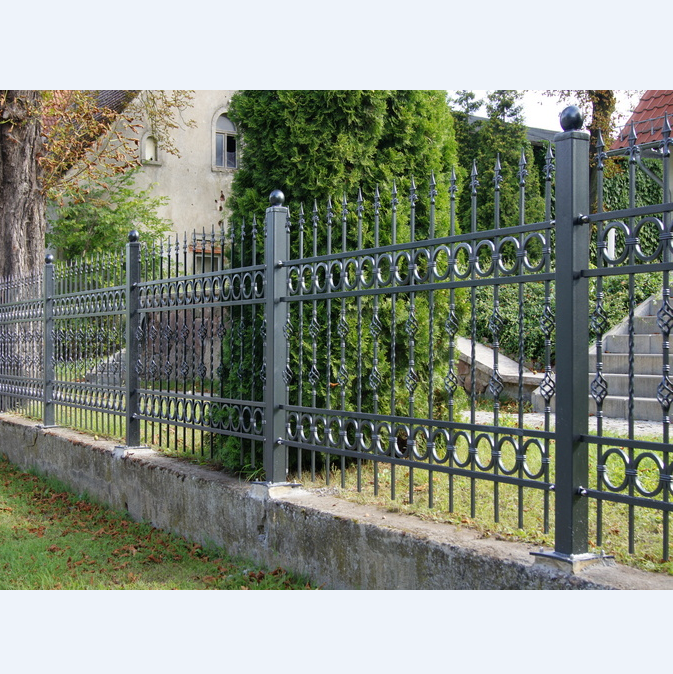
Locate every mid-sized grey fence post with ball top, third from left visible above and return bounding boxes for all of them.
[264,190,289,483]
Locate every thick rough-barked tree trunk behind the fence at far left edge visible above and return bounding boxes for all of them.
[0,90,46,277]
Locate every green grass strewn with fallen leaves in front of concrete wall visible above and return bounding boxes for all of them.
[0,457,315,590]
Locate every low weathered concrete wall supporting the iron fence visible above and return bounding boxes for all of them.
[0,414,673,590]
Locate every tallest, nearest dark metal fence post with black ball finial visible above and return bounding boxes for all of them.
[553,106,595,569]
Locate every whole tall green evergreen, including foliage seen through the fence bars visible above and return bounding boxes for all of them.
[220,91,464,467]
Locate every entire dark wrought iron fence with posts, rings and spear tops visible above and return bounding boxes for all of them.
[0,109,673,562]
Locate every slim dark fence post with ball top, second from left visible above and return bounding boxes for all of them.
[124,229,140,447]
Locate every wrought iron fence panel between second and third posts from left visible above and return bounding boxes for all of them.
[133,223,265,466]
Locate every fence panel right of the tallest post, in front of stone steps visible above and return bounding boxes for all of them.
[583,117,673,560]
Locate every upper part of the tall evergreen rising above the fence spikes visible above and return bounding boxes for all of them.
[229,90,456,238]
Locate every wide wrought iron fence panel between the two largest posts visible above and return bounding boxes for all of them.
[281,162,555,528]
